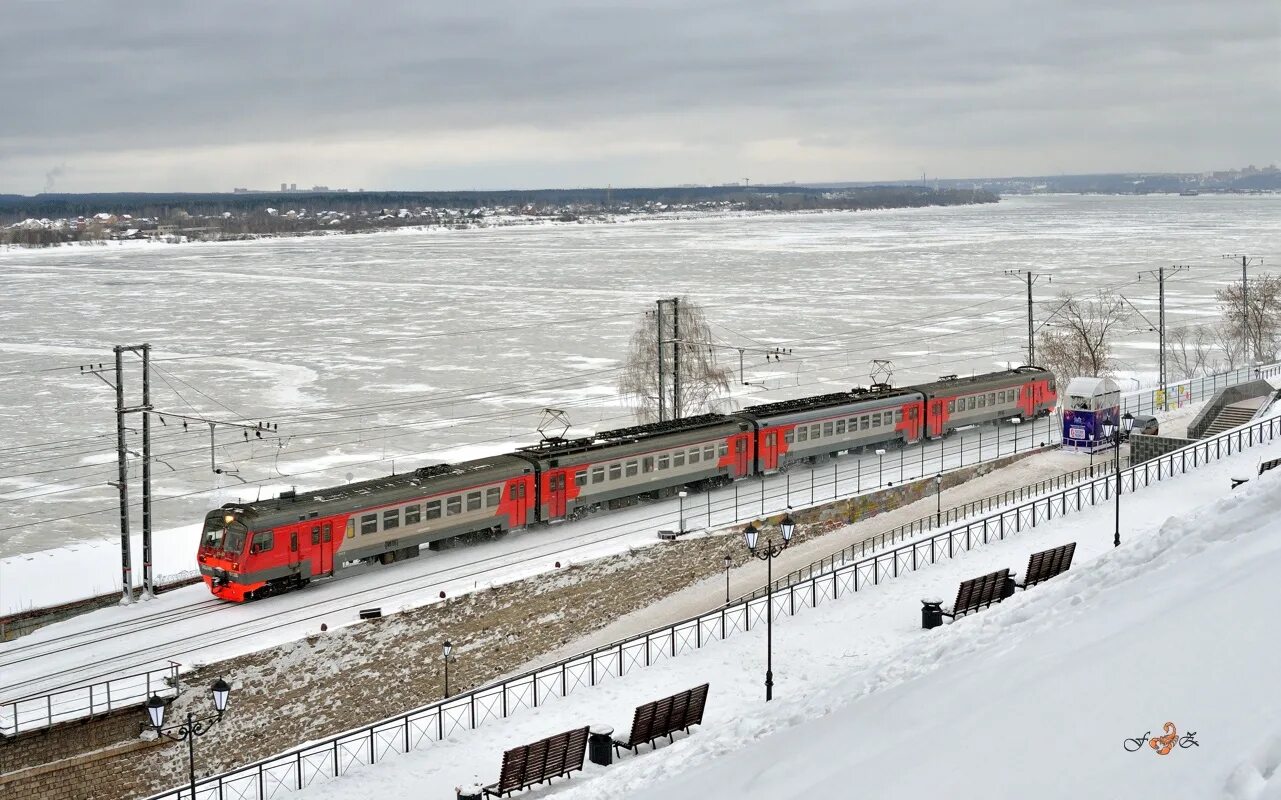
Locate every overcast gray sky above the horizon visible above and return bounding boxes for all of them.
[0,0,1281,193]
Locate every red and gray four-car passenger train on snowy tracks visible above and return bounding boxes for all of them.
[197,366,1057,602]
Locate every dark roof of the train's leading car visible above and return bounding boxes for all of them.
[223,454,532,526]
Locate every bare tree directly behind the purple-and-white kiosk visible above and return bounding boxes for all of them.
[1036,292,1130,383]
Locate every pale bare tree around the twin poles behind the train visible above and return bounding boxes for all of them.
[619,297,730,424]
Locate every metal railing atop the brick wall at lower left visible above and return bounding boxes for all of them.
[0,662,179,737]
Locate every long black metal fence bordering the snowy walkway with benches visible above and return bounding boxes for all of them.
[149,404,1281,800]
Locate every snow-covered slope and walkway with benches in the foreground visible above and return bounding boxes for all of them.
[293,430,1281,800]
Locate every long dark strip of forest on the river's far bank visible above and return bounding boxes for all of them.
[0,186,998,224]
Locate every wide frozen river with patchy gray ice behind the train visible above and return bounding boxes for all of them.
[0,196,1281,557]
